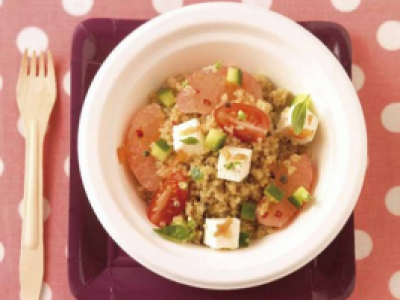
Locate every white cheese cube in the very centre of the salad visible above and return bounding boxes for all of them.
[217,146,252,182]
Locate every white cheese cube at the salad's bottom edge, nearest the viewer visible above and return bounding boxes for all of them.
[203,218,240,249]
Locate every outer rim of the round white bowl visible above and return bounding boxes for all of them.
[78,2,367,289]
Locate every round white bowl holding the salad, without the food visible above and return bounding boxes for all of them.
[78,3,367,289]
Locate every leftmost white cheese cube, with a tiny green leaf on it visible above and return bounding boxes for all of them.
[172,119,204,154]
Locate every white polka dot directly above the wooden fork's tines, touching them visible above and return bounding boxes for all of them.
[17,27,49,53]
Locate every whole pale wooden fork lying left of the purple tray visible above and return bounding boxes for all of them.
[17,50,56,300]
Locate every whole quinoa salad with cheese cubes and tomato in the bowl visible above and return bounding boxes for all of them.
[117,63,319,250]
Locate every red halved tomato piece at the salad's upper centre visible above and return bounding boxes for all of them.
[214,103,271,142]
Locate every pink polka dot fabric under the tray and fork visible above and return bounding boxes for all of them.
[0,0,400,300]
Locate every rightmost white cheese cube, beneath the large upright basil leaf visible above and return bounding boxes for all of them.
[276,106,318,144]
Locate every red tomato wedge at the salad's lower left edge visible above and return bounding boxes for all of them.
[147,172,190,227]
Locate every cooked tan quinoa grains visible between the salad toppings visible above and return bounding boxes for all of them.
[149,74,310,244]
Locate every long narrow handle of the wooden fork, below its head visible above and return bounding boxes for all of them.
[19,119,44,300]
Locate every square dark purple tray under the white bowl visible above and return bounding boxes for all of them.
[68,19,355,300]
